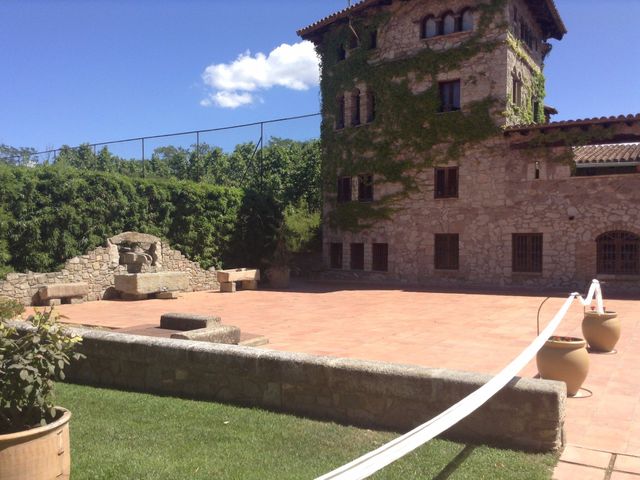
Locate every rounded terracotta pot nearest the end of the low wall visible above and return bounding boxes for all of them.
[536,337,589,396]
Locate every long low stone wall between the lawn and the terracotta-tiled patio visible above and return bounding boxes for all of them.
[17,324,566,451]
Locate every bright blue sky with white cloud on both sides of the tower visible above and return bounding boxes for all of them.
[0,0,640,156]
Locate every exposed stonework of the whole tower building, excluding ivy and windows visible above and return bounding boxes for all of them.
[299,0,640,289]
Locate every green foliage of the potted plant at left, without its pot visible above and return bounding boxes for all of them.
[0,309,81,434]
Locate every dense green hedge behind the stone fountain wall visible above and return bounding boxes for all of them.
[0,166,281,275]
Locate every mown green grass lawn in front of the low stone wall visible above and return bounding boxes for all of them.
[56,384,556,480]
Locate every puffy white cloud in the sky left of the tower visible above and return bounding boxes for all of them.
[200,41,320,108]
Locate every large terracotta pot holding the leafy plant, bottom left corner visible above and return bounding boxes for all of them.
[0,407,71,480]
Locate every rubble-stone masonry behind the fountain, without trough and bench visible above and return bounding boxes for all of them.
[0,232,220,305]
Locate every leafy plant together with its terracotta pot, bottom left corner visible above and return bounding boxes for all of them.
[0,299,81,480]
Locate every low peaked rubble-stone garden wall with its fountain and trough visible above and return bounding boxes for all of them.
[0,232,220,305]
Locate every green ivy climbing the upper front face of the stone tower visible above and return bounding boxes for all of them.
[318,0,505,231]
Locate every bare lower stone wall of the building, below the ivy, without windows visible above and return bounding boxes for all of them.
[324,137,640,294]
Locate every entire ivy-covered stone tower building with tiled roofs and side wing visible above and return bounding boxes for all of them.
[298,0,640,288]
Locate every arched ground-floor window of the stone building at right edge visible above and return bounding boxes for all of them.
[596,231,640,275]
